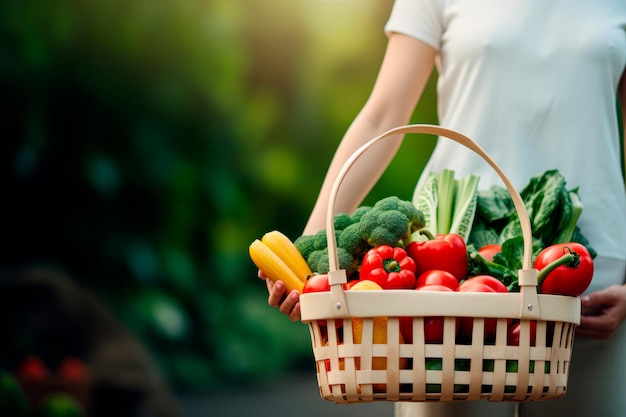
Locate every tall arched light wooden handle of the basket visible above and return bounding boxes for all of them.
[326,124,539,318]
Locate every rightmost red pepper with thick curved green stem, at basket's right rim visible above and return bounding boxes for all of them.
[534,242,594,297]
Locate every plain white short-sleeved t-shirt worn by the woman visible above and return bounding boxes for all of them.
[385,0,626,288]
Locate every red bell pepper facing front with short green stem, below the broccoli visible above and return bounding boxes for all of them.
[359,245,415,290]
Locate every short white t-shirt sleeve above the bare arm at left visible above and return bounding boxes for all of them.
[385,0,444,50]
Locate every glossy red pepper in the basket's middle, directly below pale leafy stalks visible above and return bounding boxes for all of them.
[406,233,467,281]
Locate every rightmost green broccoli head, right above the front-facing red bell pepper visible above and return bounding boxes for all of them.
[359,196,425,246]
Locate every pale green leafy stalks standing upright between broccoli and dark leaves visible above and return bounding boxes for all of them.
[413,169,479,239]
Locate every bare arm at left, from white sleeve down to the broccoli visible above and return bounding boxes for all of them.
[303,34,436,234]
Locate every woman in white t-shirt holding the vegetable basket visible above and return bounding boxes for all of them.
[268,0,626,417]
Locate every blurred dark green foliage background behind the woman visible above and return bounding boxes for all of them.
[0,0,436,391]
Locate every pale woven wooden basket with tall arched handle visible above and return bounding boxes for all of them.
[300,125,580,403]
